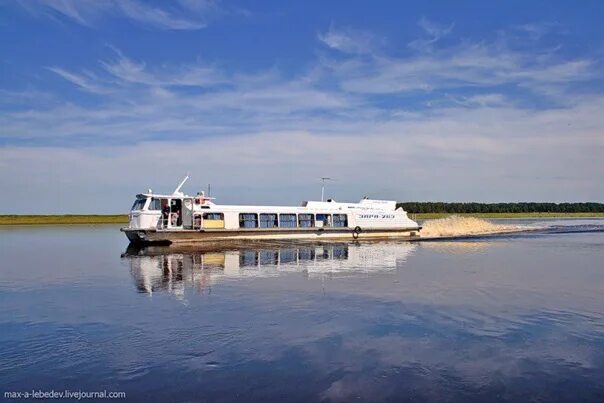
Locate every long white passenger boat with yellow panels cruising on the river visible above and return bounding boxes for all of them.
[121,176,421,244]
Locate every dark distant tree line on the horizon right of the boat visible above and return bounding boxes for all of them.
[396,202,604,213]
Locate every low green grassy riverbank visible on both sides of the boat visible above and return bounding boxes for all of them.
[0,213,604,225]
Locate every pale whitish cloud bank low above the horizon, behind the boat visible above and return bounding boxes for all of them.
[0,94,604,212]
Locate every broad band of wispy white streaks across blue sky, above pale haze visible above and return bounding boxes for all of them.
[2,21,596,144]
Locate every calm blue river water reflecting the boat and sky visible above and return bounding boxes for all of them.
[0,220,604,402]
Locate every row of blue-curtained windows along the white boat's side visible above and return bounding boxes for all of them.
[203,213,348,228]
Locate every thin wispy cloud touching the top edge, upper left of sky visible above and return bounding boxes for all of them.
[20,0,217,30]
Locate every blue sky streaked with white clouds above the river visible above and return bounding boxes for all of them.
[0,0,604,214]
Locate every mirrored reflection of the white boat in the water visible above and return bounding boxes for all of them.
[122,242,416,295]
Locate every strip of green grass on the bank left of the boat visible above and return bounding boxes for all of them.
[0,214,128,225]
